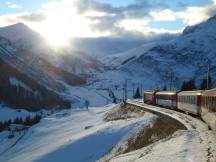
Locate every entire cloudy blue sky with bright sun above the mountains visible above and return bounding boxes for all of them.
[0,0,216,44]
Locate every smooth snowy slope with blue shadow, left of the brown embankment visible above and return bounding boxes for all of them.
[0,105,157,162]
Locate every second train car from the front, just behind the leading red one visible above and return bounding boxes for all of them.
[156,91,177,109]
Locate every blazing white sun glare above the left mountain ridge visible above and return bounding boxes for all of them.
[28,6,107,47]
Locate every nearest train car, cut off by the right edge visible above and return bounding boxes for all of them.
[201,89,216,130]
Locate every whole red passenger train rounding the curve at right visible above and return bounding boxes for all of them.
[144,89,216,130]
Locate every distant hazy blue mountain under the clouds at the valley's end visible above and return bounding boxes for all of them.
[72,34,177,58]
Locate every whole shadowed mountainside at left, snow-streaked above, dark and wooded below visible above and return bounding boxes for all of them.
[0,37,82,111]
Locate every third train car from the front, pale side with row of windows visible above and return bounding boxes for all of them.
[177,91,203,115]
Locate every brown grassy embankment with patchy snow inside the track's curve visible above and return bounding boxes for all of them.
[102,103,187,161]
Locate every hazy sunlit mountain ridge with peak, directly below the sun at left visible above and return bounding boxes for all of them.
[0,23,102,75]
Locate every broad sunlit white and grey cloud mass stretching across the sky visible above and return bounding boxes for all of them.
[0,0,216,37]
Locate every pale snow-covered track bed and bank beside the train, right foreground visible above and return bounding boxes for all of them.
[111,102,216,162]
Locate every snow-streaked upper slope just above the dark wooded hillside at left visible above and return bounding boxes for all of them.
[0,37,85,90]
